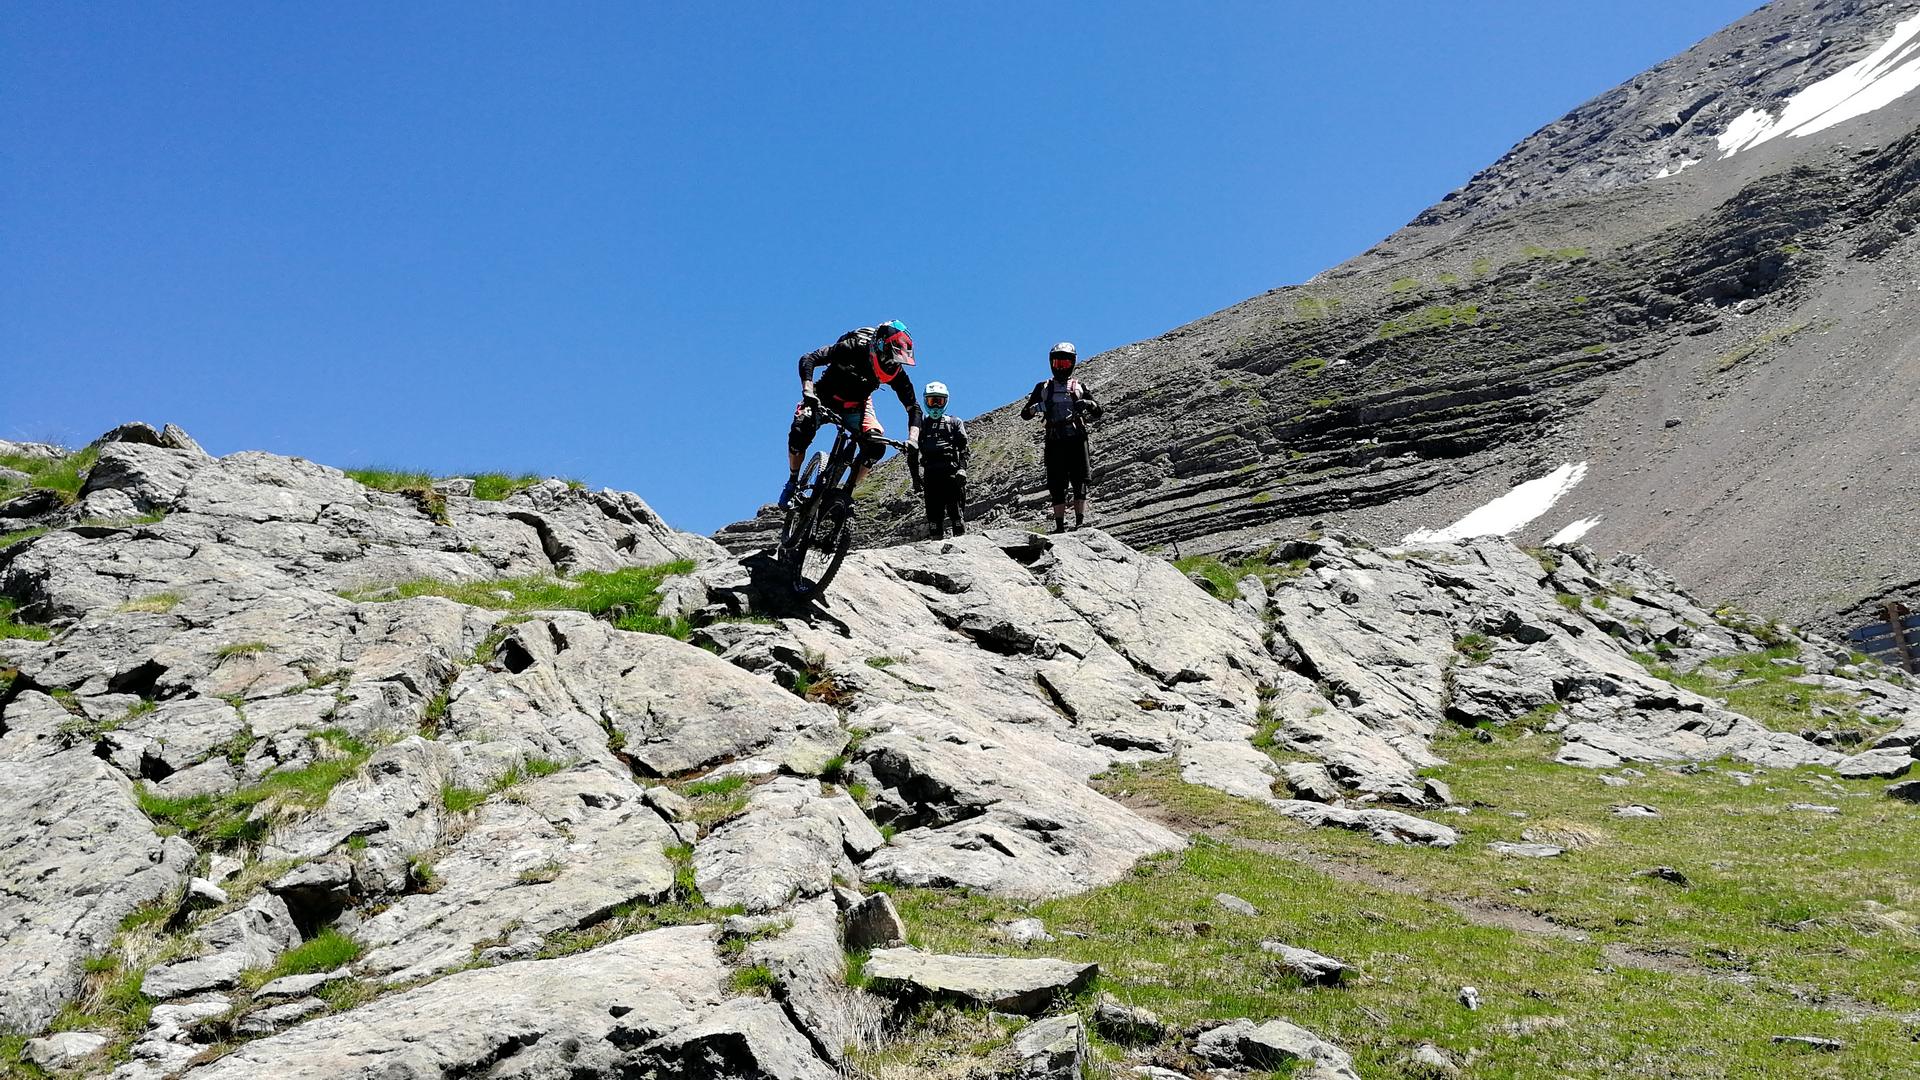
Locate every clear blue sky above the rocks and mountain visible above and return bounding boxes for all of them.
[0,0,1753,530]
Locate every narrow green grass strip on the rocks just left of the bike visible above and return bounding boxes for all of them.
[342,559,693,634]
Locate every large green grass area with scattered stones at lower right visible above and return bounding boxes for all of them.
[891,749,1920,1080]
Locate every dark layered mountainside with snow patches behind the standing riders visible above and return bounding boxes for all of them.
[802,0,1920,628]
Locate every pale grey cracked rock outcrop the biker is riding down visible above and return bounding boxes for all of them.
[0,430,1920,1080]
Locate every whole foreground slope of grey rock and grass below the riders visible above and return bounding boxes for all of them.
[0,425,1920,1080]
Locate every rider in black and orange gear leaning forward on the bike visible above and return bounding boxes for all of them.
[780,319,920,509]
